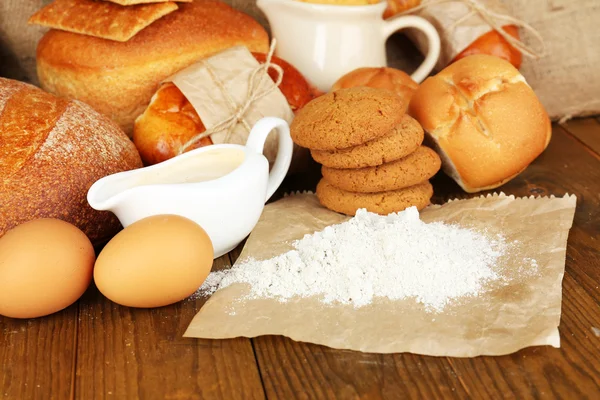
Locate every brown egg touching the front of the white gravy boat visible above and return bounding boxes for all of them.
[94,215,214,308]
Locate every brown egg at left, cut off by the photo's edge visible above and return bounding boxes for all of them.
[0,218,95,318]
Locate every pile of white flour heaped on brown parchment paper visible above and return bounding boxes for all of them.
[199,207,507,312]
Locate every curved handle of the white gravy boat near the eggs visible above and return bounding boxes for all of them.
[246,117,294,201]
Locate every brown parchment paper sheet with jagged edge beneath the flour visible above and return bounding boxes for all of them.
[185,194,576,357]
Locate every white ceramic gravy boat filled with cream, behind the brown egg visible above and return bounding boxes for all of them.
[87,117,293,258]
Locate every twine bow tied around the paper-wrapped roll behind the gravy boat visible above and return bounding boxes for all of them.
[178,39,283,154]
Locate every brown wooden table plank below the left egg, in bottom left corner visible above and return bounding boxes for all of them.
[0,304,78,400]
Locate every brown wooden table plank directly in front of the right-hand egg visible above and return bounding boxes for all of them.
[75,256,264,400]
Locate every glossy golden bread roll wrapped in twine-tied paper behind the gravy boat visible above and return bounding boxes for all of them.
[133,53,315,165]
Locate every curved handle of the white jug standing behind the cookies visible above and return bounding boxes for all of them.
[383,15,441,83]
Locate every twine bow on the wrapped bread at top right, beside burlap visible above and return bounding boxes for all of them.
[400,0,546,59]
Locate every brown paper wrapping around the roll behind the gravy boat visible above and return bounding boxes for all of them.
[165,46,294,162]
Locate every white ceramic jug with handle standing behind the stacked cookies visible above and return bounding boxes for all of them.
[256,0,440,91]
